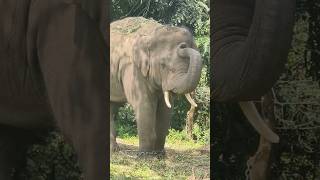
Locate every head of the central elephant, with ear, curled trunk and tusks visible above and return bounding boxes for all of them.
[133,26,202,108]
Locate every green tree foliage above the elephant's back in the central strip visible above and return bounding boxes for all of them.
[111,0,209,31]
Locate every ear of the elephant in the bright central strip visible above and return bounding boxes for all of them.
[133,36,150,77]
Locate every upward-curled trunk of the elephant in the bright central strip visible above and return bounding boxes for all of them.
[171,44,202,94]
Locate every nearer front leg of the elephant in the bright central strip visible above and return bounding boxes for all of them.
[122,70,162,152]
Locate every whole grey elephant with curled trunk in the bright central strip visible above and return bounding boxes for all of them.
[110,17,202,155]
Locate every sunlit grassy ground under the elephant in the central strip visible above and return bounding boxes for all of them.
[110,133,210,180]
